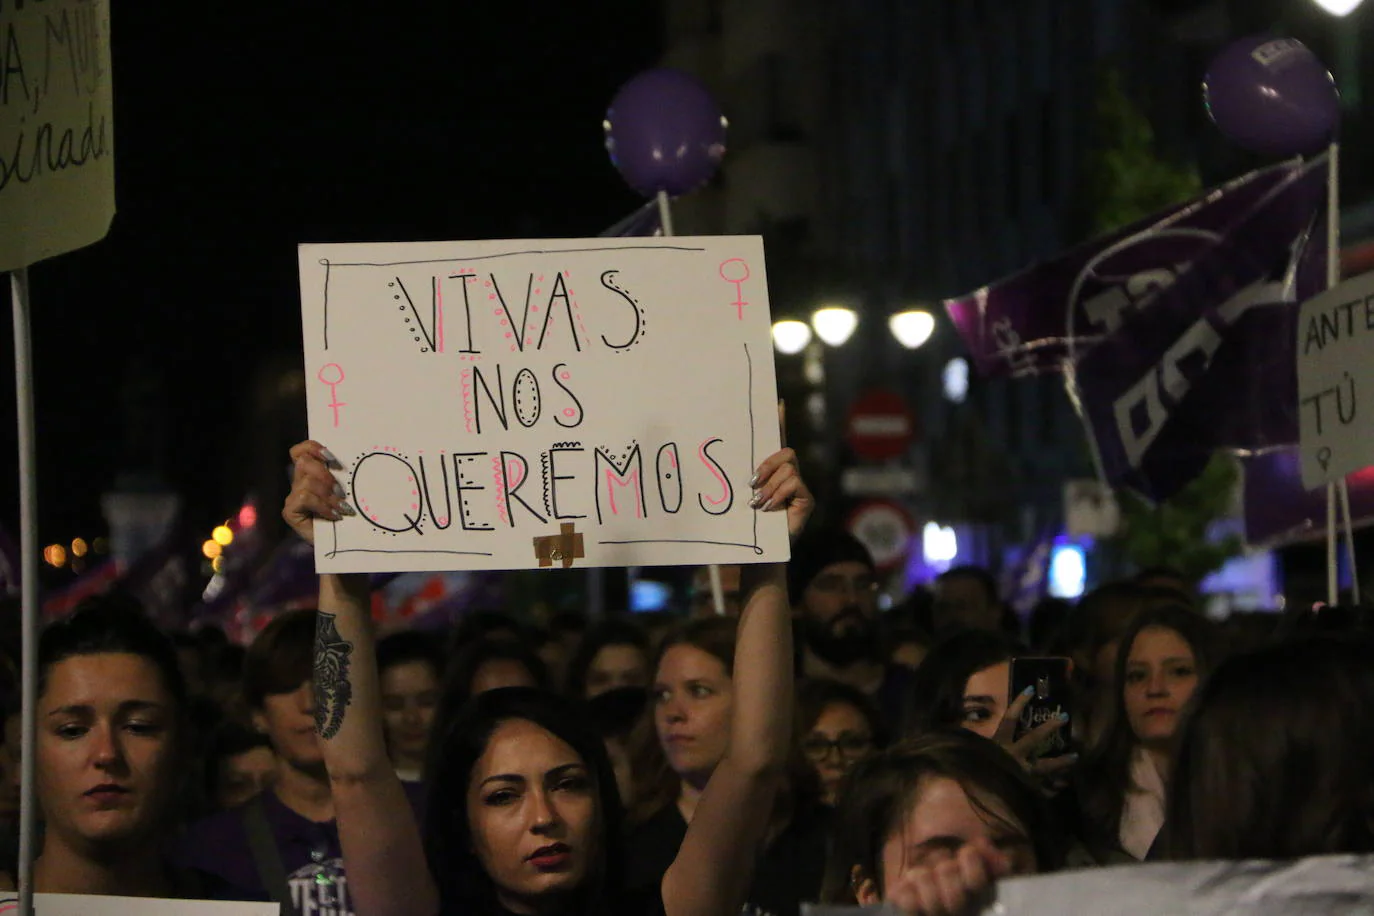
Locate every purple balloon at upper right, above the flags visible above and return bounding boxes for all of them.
[1202,37,1341,157]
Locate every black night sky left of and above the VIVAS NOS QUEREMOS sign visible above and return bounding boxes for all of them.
[0,0,661,552]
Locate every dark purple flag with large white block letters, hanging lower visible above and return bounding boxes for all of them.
[1068,157,1327,500]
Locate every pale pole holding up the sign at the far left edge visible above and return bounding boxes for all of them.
[10,268,38,916]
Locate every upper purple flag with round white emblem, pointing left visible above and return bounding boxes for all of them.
[945,161,1305,376]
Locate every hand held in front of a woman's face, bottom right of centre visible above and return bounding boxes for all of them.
[883,838,1011,916]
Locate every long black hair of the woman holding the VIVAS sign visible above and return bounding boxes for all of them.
[425,687,624,916]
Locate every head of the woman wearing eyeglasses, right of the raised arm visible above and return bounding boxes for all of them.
[797,680,888,808]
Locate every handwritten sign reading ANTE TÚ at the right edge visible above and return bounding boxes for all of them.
[1297,273,1374,489]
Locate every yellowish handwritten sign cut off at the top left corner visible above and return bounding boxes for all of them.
[0,0,114,271]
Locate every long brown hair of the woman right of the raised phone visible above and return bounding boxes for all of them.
[1077,604,1220,851]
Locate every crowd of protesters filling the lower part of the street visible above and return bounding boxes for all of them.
[0,442,1374,916]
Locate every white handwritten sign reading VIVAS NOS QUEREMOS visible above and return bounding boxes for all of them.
[300,238,787,571]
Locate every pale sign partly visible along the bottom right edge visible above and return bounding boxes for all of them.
[801,856,1374,916]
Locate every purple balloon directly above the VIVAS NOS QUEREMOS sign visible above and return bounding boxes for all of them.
[605,69,725,198]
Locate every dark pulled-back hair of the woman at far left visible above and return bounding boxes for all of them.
[38,592,187,714]
